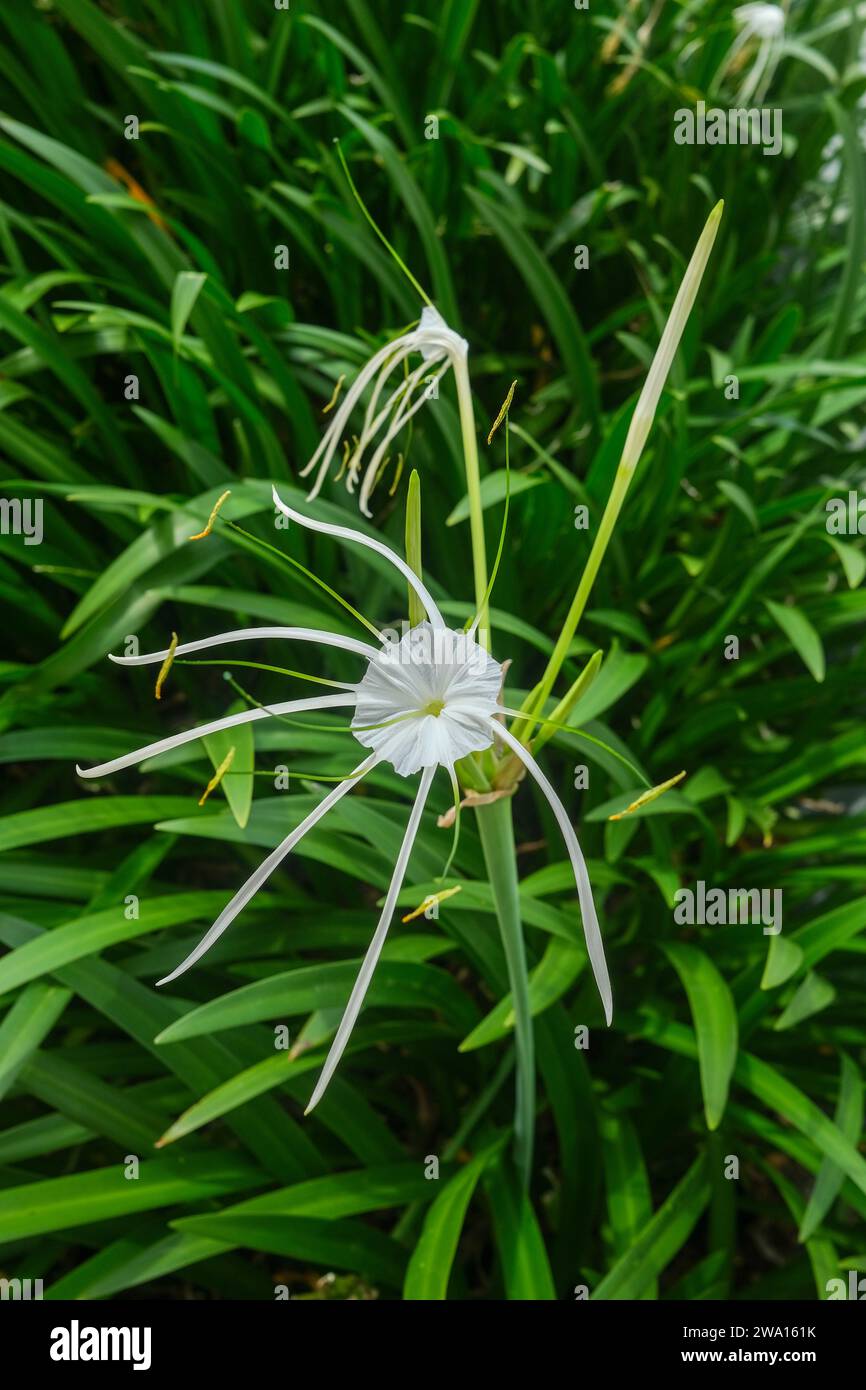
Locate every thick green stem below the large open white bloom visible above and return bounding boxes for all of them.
[475,796,535,1187]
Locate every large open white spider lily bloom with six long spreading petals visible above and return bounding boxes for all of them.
[78,488,613,1113]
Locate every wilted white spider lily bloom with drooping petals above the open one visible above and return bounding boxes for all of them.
[300,304,468,516]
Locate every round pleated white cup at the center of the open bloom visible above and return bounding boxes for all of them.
[352,623,502,777]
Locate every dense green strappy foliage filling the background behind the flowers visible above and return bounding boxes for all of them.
[0,0,866,1300]
